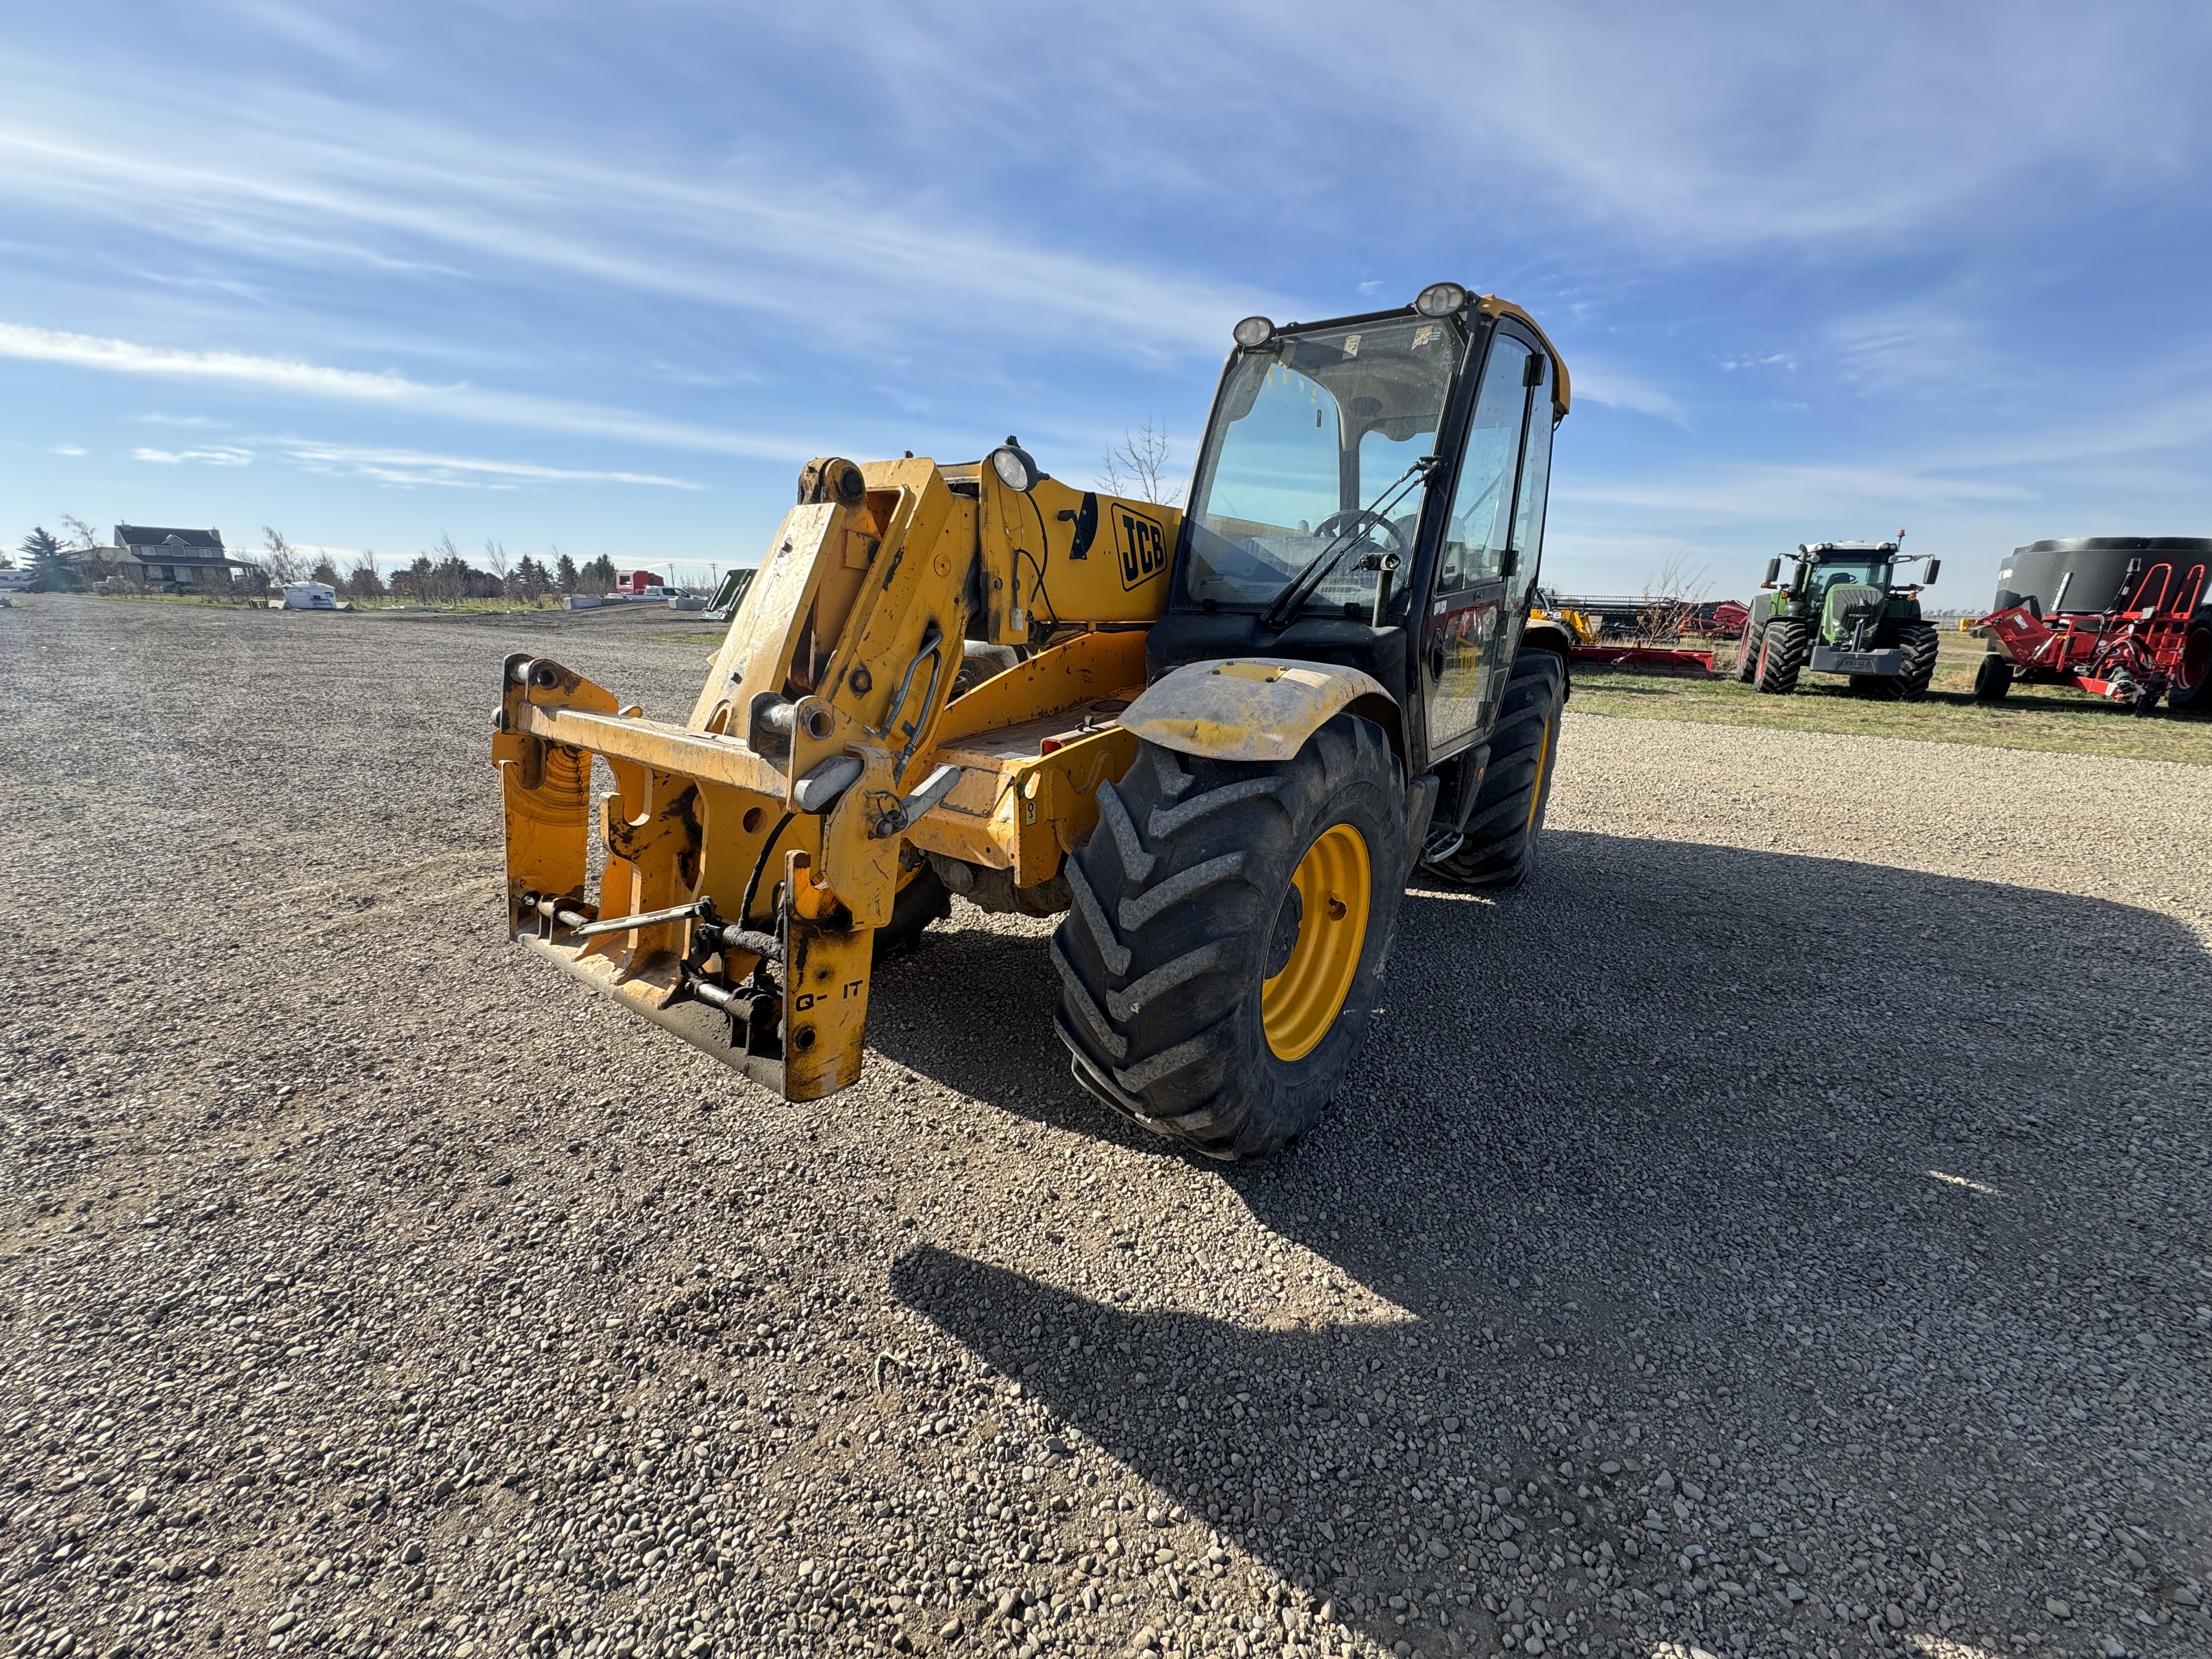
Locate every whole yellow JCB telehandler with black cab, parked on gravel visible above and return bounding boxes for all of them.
[493,283,1568,1157]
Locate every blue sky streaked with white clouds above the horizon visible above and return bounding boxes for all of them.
[0,0,2212,604]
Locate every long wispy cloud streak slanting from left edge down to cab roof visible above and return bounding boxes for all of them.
[0,97,1281,354]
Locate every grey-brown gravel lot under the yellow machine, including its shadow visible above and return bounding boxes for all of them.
[0,600,2212,1659]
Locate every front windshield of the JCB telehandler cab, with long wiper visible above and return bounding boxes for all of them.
[1186,319,1460,613]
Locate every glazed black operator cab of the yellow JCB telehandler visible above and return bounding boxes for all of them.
[1146,283,1568,772]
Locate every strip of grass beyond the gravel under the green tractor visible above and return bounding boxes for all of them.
[1573,633,2212,765]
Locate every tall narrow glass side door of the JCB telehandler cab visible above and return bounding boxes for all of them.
[1420,330,1550,759]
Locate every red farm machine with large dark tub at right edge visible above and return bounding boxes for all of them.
[1973,535,2212,714]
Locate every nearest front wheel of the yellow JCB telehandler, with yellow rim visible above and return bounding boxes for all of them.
[1051,714,1407,1159]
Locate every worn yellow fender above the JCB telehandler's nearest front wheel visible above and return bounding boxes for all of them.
[1121,657,1396,761]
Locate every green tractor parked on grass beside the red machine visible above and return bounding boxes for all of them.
[1736,542,1942,701]
